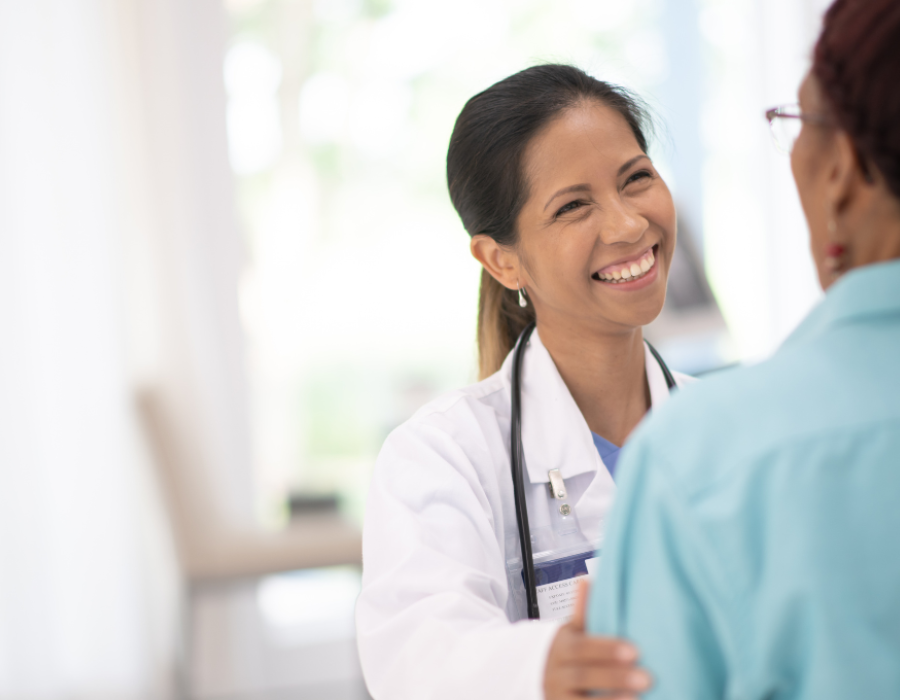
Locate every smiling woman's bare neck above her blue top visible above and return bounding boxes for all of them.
[538,320,650,446]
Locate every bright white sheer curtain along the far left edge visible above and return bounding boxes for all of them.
[0,0,182,700]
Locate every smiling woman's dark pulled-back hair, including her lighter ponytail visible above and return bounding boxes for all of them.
[447,64,649,379]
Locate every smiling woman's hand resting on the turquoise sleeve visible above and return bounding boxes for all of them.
[544,576,650,700]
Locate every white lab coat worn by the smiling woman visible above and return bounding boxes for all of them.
[356,331,690,700]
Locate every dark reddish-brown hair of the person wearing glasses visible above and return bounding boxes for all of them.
[812,0,900,198]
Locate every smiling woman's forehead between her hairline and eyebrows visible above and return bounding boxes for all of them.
[523,102,642,189]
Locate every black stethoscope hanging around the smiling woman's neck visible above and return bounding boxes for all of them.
[509,321,676,620]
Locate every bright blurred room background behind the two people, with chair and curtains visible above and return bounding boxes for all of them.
[0,0,826,700]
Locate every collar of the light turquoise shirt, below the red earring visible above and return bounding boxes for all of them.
[785,260,900,346]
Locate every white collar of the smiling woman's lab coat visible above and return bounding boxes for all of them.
[502,329,669,484]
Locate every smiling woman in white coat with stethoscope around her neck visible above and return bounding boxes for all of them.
[356,65,686,700]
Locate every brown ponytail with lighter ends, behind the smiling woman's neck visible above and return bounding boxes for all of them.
[478,269,534,380]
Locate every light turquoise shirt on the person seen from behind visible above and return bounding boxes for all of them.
[588,261,900,700]
